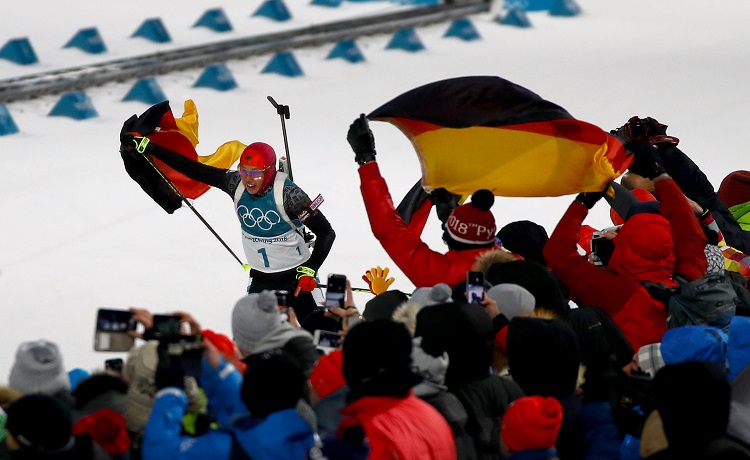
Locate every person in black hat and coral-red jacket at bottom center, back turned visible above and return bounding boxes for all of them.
[338,319,456,460]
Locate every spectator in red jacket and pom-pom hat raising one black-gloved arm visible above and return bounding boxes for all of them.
[346,114,496,288]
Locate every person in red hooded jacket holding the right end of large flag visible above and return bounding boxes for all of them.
[544,146,706,350]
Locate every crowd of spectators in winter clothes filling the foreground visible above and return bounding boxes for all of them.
[0,113,750,460]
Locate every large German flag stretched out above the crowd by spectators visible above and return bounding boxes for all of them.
[368,76,632,197]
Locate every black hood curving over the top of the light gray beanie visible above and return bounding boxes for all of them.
[484,260,570,318]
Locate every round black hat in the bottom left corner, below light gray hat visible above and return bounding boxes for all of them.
[5,393,73,452]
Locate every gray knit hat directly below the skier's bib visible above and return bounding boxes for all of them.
[232,291,282,353]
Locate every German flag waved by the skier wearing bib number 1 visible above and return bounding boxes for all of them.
[121,100,246,214]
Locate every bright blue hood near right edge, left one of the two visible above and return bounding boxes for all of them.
[661,325,729,368]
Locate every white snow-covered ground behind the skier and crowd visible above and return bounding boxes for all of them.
[0,0,750,384]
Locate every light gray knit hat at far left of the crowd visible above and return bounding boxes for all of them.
[8,339,70,395]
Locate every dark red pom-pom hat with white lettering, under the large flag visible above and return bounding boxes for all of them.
[445,189,496,245]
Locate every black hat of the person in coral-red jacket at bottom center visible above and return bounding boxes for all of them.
[343,320,422,400]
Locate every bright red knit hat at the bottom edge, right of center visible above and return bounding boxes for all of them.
[500,396,563,452]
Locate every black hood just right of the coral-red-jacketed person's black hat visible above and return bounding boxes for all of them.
[414,302,495,386]
